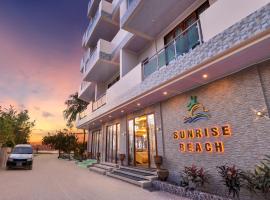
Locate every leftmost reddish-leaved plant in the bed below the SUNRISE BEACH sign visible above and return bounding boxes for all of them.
[180,165,209,191]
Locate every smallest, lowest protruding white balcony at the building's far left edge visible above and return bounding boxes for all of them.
[78,81,95,102]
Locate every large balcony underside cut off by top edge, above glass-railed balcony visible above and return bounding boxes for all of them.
[120,0,196,40]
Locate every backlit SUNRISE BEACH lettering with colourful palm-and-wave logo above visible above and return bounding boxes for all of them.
[173,96,232,153]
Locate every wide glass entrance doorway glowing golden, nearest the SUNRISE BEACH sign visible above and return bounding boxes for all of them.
[128,114,156,167]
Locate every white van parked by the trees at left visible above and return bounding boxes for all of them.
[6,144,33,170]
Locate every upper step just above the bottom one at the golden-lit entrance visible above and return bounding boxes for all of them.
[114,167,157,181]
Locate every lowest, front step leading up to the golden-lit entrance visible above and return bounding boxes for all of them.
[107,170,152,188]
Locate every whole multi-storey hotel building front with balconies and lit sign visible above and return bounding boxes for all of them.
[77,0,270,197]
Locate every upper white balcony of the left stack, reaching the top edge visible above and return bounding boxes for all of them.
[82,0,119,47]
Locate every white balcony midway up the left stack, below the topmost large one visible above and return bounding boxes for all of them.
[83,39,119,82]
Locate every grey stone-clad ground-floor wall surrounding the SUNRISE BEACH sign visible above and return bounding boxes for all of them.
[162,62,270,199]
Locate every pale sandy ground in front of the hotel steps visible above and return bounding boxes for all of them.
[0,155,190,200]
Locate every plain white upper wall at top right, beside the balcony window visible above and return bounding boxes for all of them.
[200,0,270,42]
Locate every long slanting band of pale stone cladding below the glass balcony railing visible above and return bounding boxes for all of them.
[79,3,270,124]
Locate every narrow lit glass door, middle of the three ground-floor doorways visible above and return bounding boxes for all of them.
[105,124,120,163]
